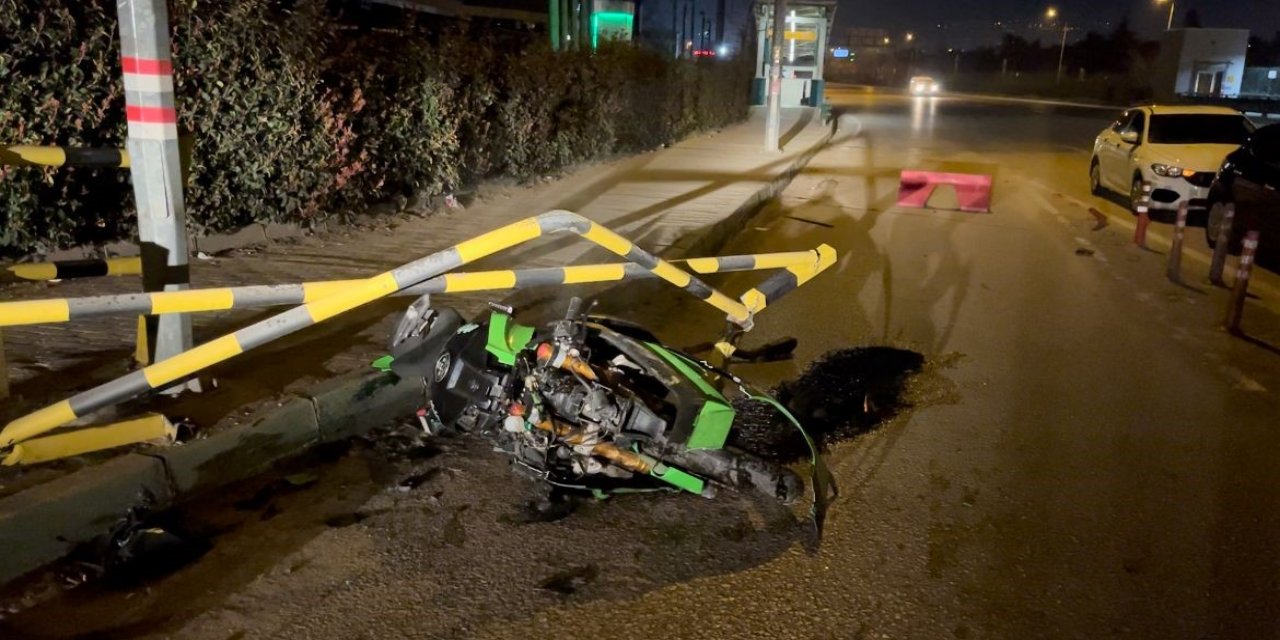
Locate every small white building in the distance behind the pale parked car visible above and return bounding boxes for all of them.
[1152,28,1249,100]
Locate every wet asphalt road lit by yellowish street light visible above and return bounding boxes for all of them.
[0,88,1280,640]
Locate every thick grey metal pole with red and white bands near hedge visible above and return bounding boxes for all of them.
[116,0,191,376]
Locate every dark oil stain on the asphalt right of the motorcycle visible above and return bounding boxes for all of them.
[730,347,924,462]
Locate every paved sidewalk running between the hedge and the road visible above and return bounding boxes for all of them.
[0,110,833,582]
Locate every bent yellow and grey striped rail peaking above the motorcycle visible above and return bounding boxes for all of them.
[0,210,835,448]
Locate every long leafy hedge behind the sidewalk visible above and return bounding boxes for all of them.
[0,0,751,256]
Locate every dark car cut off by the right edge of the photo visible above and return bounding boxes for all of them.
[1204,124,1280,266]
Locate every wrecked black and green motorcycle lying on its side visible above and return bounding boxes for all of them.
[376,296,836,530]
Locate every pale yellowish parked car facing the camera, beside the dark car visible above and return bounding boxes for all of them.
[1089,105,1254,211]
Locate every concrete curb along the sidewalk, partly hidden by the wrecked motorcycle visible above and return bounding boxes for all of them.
[0,122,836,584]
